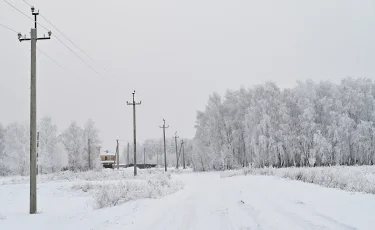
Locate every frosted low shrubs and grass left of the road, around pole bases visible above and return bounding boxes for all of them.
[0,168,183,208]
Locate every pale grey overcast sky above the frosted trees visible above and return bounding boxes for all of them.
[0,0,375,151]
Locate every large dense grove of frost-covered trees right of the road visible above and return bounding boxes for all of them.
[192,78,375,170]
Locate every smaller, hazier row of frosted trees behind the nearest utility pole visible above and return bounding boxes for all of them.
[0,117,100,175]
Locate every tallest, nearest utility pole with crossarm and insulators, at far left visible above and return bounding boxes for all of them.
[18,7,52,214]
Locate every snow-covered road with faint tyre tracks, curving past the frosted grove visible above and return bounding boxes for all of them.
[134,173,375,230]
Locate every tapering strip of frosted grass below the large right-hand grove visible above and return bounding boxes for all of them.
[221,166,375,194]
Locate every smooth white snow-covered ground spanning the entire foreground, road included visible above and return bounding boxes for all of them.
[0,169,375,230]
